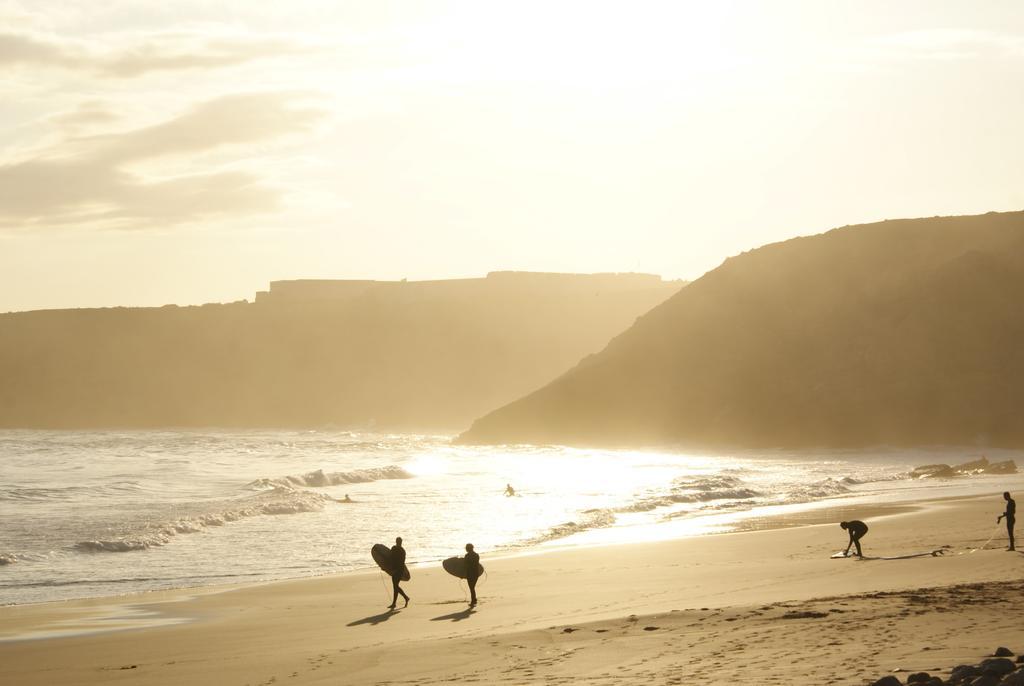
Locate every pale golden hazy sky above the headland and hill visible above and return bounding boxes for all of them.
[0,0,1024,311]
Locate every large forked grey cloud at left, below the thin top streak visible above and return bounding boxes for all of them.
[0,93,322,230]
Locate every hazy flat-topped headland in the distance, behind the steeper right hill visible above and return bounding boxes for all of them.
[0,271,683,430]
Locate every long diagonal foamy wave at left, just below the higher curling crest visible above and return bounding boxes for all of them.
[74,486,331,553]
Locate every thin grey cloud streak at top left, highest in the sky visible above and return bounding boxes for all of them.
[0,31,305,78]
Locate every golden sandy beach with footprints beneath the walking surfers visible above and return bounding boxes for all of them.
[0,494,1024,686]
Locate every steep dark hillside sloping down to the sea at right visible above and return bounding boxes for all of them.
[461,212,1024,447]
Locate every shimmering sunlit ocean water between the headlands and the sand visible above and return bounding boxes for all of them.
[0,431,1021,604]
